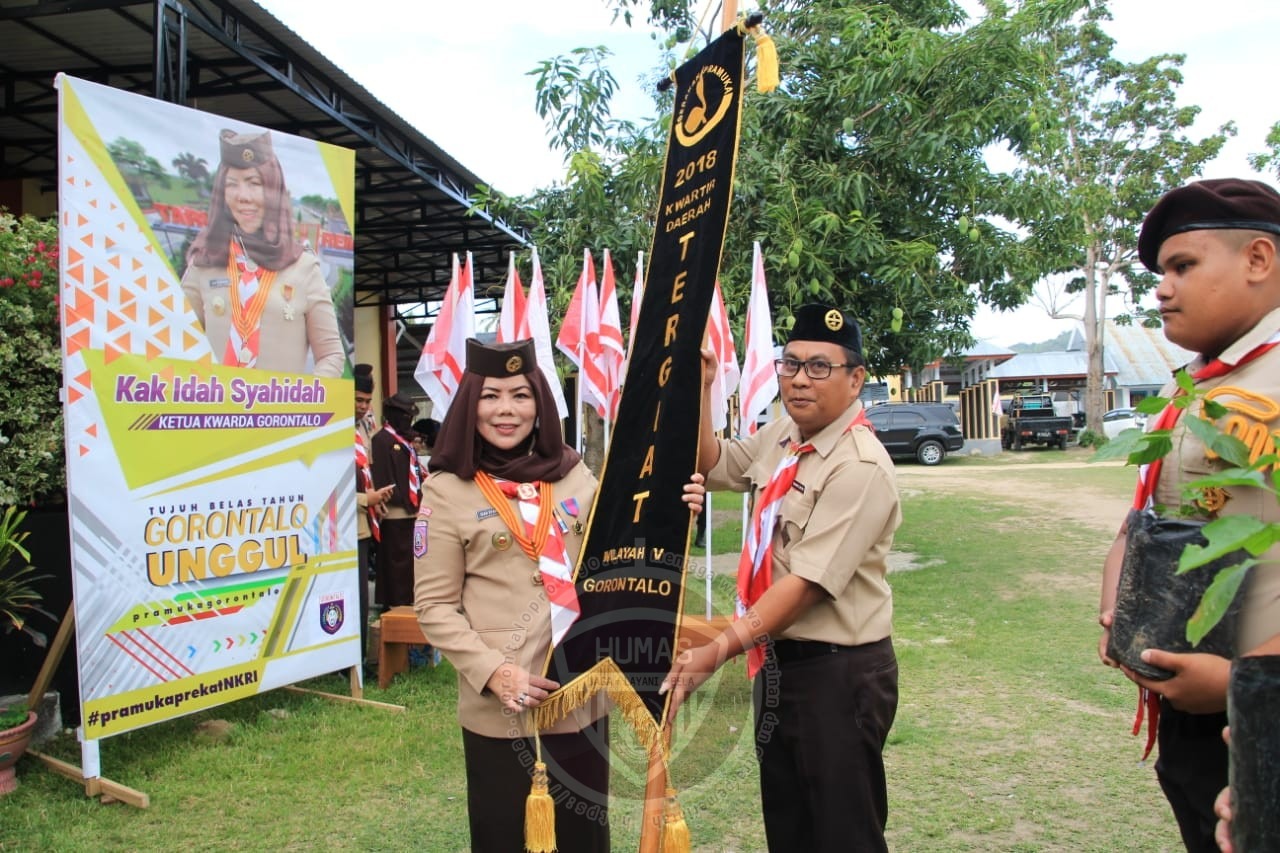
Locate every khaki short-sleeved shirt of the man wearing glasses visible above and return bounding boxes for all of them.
[707,402,902,646]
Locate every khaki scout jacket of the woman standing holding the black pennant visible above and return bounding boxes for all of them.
[413,462,607,738]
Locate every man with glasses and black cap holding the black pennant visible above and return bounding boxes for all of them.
[663,305,901,852]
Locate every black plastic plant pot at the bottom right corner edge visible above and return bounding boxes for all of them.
[1226,654,1280,853]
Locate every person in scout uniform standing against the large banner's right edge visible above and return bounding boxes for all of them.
[371,391,422,607]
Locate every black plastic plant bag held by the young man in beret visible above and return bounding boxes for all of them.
[1107,510,1248,679]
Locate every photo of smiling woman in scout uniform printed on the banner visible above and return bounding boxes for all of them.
[182,129,346,377]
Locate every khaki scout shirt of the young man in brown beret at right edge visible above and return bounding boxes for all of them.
[1155,309,1280,653]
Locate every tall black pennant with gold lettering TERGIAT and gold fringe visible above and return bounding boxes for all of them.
[548,29,742,724]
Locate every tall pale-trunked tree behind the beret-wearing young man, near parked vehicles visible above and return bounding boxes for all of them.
[1011,4,1235,429]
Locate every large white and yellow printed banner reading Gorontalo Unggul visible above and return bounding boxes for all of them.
[58,76,362,739]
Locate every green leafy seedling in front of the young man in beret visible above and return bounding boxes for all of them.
[1093,370,1280,646]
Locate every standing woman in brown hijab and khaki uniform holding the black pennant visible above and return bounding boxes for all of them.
[413,338,704,853]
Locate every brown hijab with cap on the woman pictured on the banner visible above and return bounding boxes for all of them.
[187,131,302,270]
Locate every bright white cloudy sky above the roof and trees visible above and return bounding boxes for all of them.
[259,0,1280,346]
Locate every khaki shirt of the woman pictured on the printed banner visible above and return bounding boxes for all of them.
[182,252,346,377]
